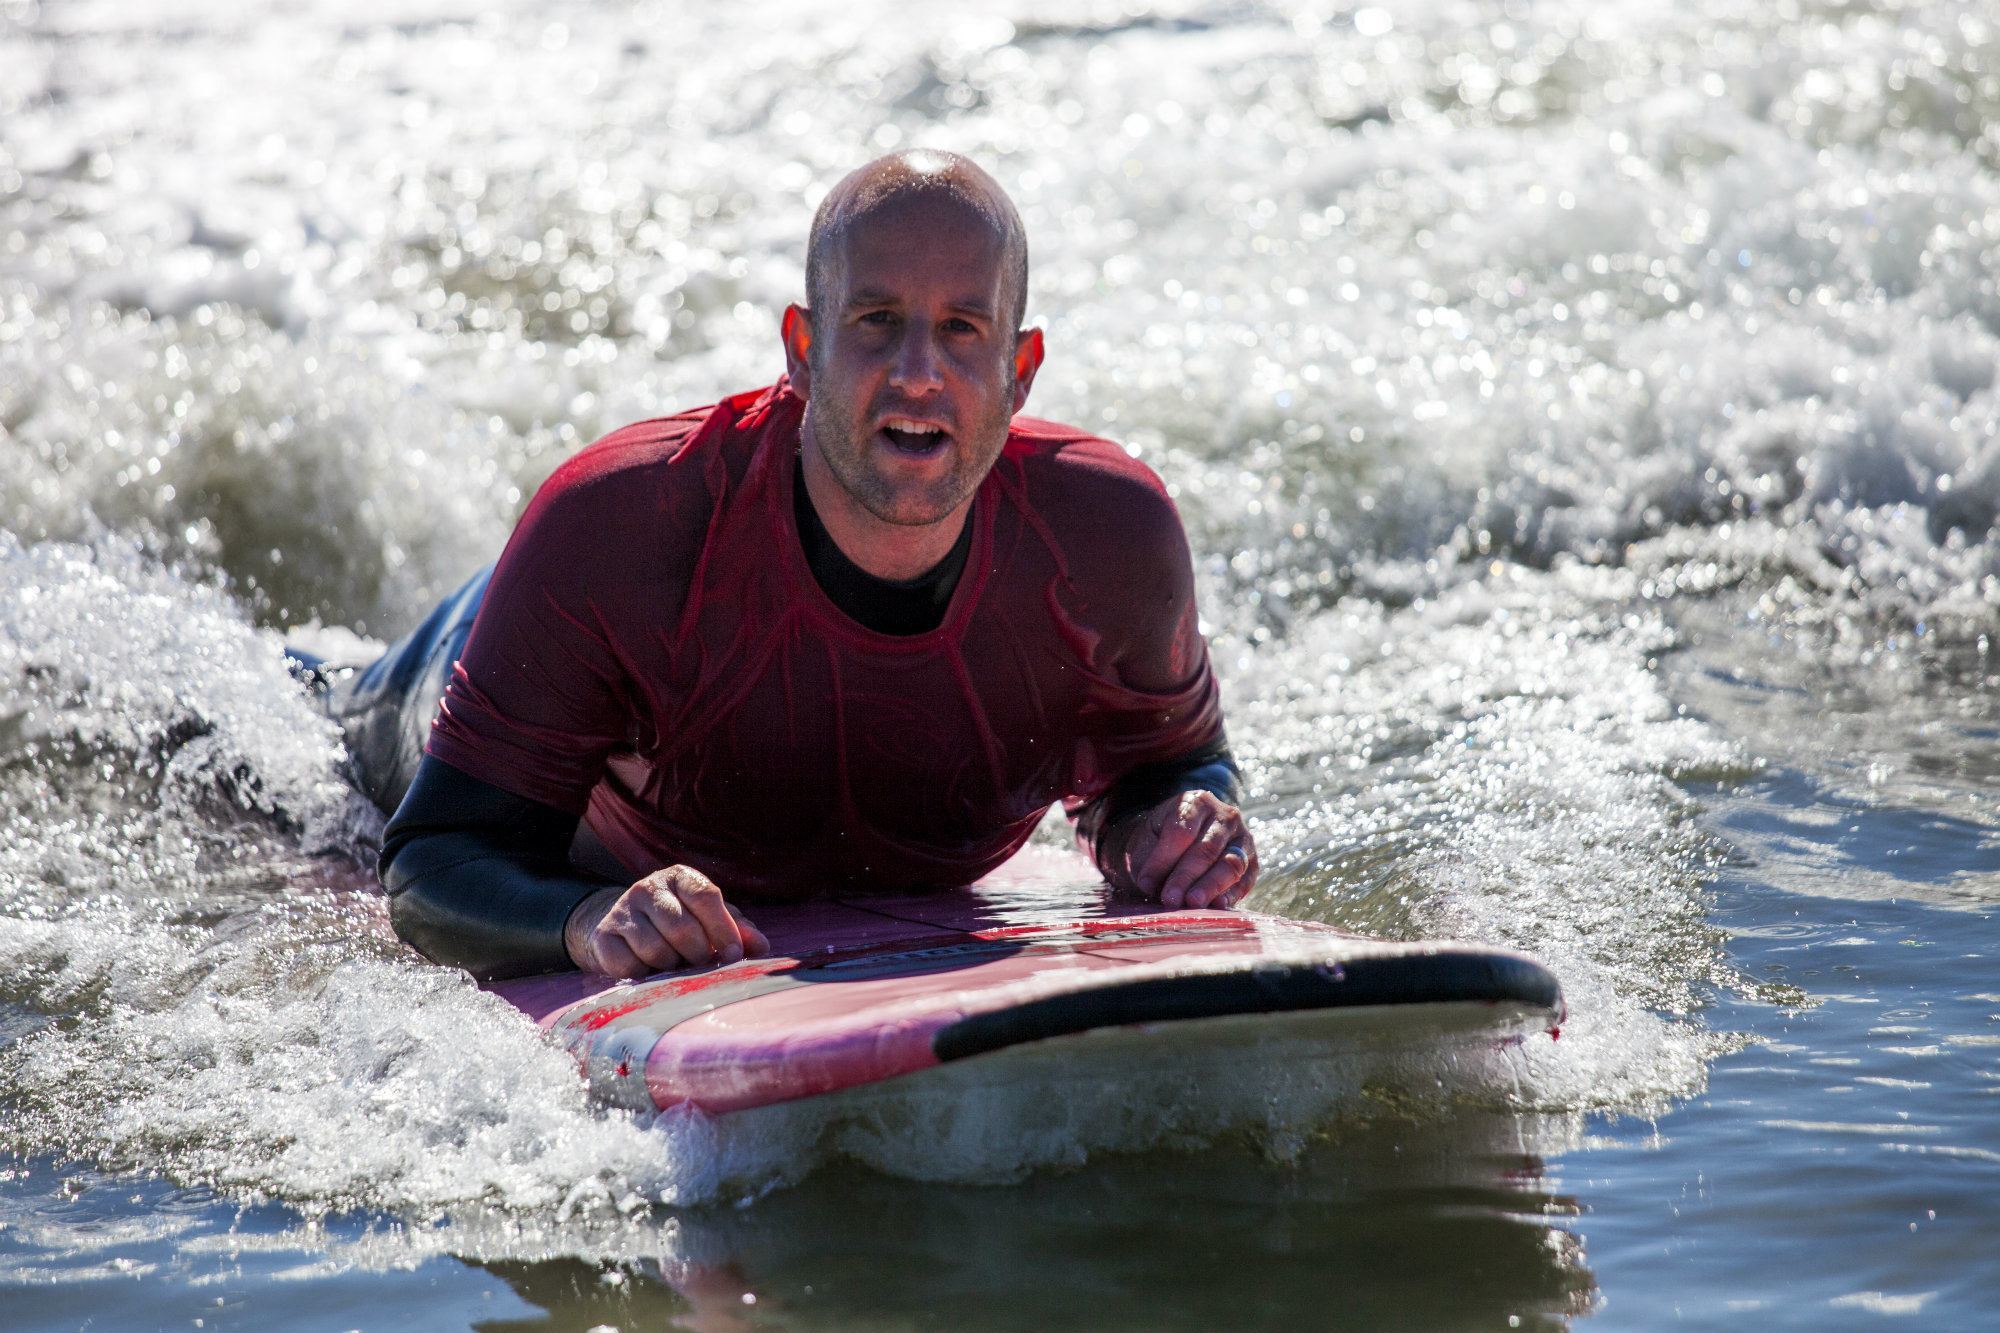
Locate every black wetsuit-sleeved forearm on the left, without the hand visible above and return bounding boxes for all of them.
[380,757,606,981]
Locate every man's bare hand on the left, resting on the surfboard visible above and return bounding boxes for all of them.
[562,865,770,977]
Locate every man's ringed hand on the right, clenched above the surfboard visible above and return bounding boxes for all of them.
[1100,791,1258,907]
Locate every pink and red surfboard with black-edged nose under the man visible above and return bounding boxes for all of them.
[490,891,1564,1113]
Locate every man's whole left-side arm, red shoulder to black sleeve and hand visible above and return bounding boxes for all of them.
[380,430,766,979]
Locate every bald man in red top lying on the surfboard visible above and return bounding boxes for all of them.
[330,150,1258,977]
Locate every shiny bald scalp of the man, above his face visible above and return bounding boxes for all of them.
[806,148,1028,338]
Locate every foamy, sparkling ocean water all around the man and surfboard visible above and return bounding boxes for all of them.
[0,0,2000,1331]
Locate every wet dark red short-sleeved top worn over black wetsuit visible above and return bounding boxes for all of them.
[426,380,1222,901]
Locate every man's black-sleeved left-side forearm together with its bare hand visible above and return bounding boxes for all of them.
[380,755,770,981]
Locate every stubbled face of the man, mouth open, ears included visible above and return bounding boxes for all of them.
[786,196,1040,526]
